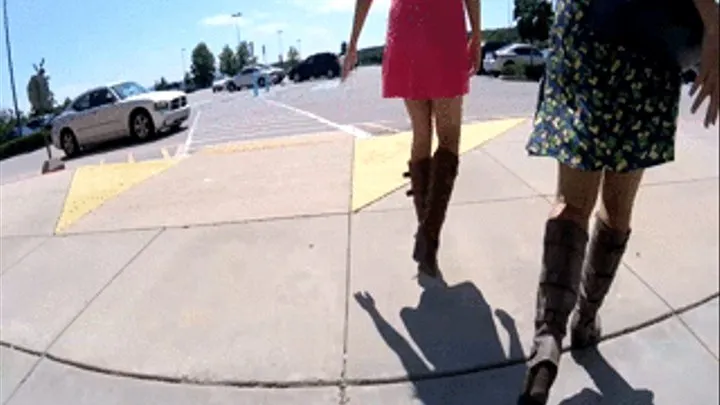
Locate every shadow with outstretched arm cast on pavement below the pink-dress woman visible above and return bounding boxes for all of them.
[355,275,526,405]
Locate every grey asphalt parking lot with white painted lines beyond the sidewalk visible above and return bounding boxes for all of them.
[0,66,537,183]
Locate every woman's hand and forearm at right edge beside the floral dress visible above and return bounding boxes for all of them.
[690,24,720,128]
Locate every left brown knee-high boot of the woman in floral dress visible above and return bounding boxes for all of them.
[518,219,588,405]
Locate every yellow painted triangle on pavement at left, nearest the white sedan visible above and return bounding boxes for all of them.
[55,159,178,233]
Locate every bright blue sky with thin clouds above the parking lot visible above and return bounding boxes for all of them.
[0,0,512,111]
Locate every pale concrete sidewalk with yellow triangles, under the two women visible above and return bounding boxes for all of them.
[0,120,720,405]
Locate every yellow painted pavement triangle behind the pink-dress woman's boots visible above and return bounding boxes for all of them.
[352,118,527,212]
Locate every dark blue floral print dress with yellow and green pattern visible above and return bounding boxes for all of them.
[526,0,681,172]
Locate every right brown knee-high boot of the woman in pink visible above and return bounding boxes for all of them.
[414,147,460,277]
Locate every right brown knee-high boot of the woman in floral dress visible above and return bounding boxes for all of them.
[570,218,630,349]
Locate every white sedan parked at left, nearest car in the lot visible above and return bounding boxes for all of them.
[51,82,190,157]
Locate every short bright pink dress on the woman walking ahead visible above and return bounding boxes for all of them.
[383,0,470,100]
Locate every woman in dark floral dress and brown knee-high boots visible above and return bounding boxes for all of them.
[519,0,720,404]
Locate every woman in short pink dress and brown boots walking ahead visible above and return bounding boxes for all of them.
[343,0,481,277]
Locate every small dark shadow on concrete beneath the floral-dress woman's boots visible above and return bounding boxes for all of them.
[560,348,655,405]
